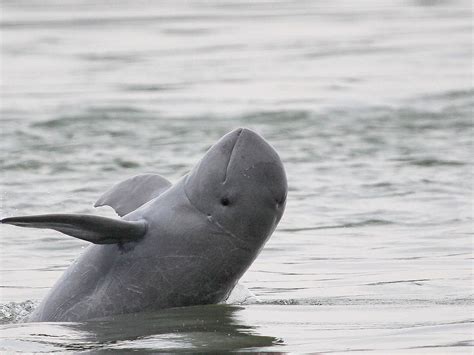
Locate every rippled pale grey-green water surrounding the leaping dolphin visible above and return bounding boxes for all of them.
[0,0,474,353]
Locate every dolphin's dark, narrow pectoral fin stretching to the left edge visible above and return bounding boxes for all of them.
[0,214,147,244]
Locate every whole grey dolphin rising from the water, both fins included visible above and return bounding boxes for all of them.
[1,128,288,322]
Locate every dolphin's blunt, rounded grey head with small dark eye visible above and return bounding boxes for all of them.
[184,128,288,249]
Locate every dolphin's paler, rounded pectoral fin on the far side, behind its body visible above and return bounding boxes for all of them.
[94,174,171,216]
